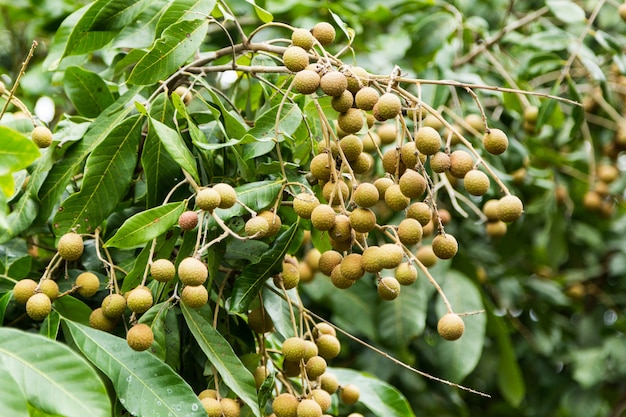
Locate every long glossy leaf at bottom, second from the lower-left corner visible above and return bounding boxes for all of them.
[63,319,206,417]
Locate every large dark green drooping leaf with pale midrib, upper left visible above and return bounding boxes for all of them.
[54,115,143,234]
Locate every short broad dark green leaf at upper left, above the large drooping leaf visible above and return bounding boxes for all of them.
[63,67,115,117]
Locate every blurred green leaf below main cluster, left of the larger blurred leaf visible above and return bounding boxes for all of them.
[376,280,428,348]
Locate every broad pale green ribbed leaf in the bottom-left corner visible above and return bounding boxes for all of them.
[0,328,111,417]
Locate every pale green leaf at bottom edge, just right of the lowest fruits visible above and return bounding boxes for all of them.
[328,368,415,417]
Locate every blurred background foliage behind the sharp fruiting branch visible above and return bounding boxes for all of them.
[0,0,626,417]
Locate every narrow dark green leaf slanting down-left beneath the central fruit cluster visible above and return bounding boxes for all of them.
[231,222,302,313]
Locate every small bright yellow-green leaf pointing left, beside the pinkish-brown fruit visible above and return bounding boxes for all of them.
[104,201,187,249]
